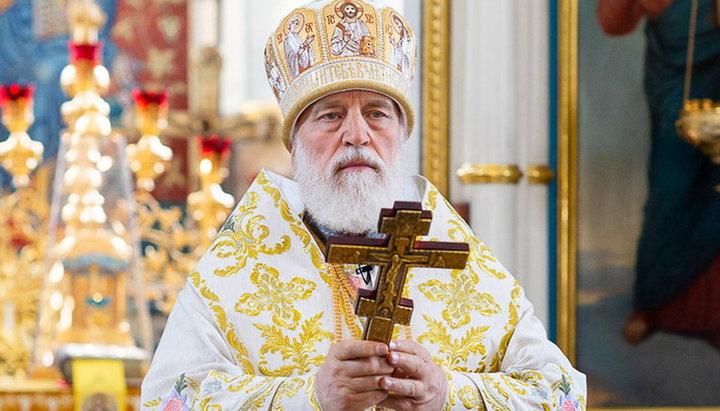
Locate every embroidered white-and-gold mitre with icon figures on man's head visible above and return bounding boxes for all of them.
[265,0,416,149]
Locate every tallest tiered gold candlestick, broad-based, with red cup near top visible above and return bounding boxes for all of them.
[34,0,152,384]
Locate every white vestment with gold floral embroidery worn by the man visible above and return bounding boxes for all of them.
[142,171,586,410]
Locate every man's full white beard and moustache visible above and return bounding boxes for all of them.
[293,140,406,234]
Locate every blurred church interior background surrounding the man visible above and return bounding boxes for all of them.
[0,0,720,411]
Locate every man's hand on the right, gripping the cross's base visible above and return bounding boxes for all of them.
[378,340,448,411]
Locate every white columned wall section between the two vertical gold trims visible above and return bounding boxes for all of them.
[450,0,548,322]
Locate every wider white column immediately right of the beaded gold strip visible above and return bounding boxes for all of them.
[450,0,518,264]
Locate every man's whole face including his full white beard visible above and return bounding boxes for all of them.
[292,91,406,234]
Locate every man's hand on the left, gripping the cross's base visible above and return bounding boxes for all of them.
[315,340,394,411]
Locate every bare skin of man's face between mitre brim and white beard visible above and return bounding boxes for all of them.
[295,90,404,183]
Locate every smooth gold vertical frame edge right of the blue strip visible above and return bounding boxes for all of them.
[557,0,578,363]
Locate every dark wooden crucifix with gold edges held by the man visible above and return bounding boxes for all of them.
[325,201,469,343]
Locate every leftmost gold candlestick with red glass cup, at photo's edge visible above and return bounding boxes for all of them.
[0,84,48,378]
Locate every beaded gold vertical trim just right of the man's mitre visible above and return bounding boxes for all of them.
[422,0,450,197]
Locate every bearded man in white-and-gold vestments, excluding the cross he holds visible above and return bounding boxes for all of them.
[142,0,586,411]
